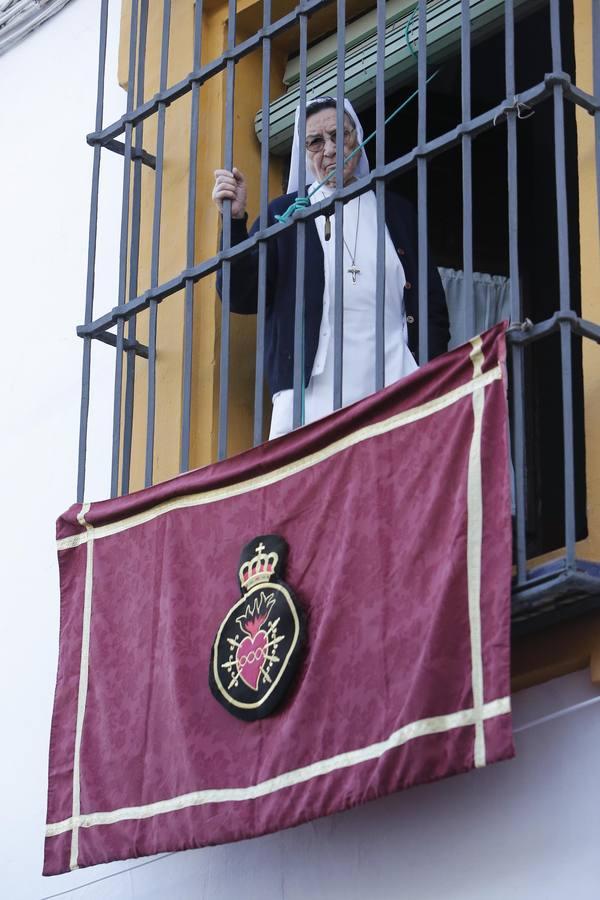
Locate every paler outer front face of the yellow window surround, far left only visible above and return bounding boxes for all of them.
[119,0,193,490]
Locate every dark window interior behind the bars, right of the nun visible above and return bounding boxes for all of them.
[361,2,587,556]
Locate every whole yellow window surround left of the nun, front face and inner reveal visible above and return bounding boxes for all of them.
[119,0,287,490]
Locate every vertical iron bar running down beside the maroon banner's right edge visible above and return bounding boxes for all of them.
[504,0,527,584]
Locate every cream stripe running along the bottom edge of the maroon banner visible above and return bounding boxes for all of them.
[46,697,510,837]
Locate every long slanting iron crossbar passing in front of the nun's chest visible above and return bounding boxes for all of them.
[77,73,596,337]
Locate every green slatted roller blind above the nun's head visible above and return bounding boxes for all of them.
[254,0,542,155]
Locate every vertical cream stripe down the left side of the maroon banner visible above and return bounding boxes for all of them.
[69,503,94,869]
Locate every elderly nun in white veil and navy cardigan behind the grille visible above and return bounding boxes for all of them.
[213,97,449,438]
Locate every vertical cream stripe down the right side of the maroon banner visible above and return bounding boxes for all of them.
[467,337,486,768]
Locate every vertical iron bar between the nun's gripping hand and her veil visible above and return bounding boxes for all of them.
[253,0,271,446]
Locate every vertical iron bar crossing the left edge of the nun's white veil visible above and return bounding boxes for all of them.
[293,12,308,428]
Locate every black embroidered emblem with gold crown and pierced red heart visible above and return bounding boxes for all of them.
[209,534,305,721]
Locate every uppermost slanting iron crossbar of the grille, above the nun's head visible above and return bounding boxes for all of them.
[87,0,331,147]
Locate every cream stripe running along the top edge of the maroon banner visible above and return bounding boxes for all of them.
[56,366,502,550]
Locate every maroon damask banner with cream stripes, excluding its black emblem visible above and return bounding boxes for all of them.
[44,326,513,875]
